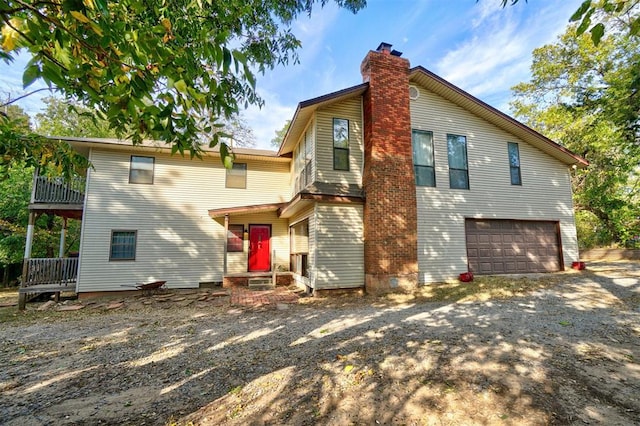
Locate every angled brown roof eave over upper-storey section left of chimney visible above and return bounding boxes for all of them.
[278,83,369,155]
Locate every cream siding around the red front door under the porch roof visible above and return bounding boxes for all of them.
[220,212,289,274]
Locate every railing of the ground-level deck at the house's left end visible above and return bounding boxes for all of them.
[22,257,78,288]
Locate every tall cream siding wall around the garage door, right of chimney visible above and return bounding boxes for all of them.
[411,88,578,283]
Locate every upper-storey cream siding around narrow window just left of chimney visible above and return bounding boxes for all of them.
[316,97,364,185]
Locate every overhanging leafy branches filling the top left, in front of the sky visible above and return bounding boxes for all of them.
[0,0,365,170]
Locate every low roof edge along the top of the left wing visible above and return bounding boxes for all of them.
[48,136,289,161]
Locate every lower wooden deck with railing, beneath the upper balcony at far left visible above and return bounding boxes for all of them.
[20,257,78,293]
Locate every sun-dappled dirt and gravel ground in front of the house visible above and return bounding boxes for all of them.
[0,262,640,426]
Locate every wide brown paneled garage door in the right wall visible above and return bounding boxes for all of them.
[465,219,561,274]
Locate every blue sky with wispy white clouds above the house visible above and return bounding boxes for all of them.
[0,0,582,148]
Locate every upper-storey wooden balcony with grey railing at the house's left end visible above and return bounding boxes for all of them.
[29,174,86,219]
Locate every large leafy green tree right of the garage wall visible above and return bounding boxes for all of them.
[511,25,640,246]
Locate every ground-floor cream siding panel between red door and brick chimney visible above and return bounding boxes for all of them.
[315,204,364,289]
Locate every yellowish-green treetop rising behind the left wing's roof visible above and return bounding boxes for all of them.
[35,96,116,138]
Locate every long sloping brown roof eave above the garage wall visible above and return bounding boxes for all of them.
[409,66,589,167]
